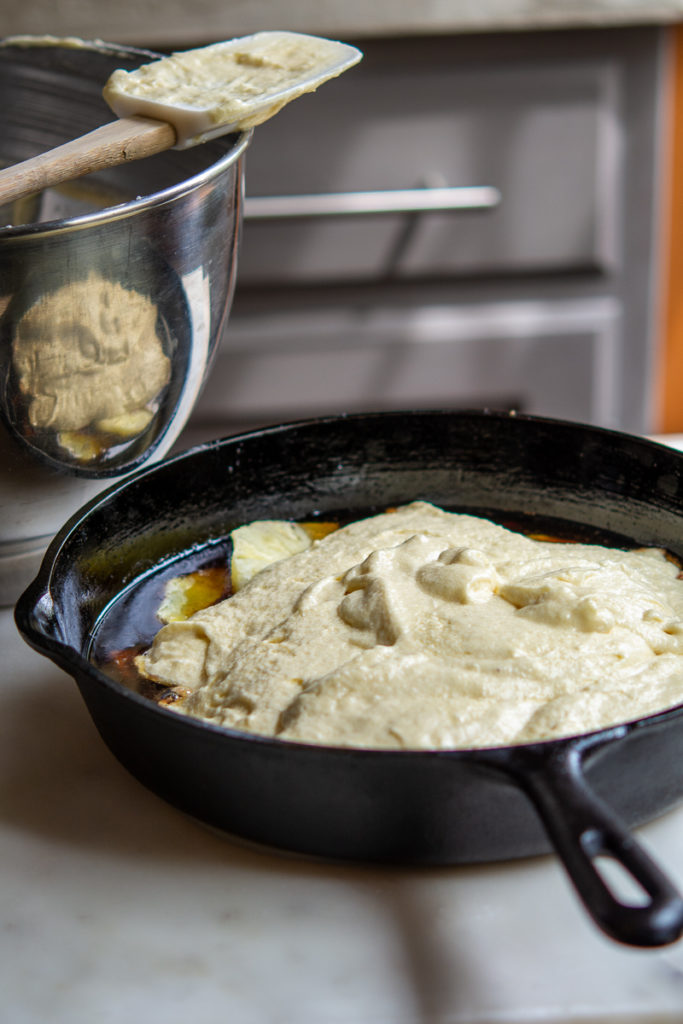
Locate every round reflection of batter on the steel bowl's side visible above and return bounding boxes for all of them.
[12,272,171,461]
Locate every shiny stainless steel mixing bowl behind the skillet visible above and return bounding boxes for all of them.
[0,37,250,604]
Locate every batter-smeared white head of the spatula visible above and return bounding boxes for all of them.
[102,32,362,148]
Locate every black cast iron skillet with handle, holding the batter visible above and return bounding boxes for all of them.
[15,412,683,946]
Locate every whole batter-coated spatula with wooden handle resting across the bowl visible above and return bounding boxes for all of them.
[0,32,362,206]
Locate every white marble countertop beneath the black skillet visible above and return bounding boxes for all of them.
[0,577,683,1024]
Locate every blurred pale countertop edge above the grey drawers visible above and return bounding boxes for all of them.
[0,0,683,47]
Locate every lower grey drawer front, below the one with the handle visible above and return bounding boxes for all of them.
[191,299,618,436]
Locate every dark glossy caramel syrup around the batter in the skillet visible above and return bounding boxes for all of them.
[88,509,679,703]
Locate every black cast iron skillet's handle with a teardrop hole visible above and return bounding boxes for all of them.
[505,742,683,946]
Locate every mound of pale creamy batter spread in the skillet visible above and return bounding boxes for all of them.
[137,502,683,750]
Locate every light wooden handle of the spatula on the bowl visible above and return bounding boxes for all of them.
[0,117,176,206]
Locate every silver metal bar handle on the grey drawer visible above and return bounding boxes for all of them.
[244,185,501,220]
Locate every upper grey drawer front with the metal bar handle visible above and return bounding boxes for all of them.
[239,39,621,285]
